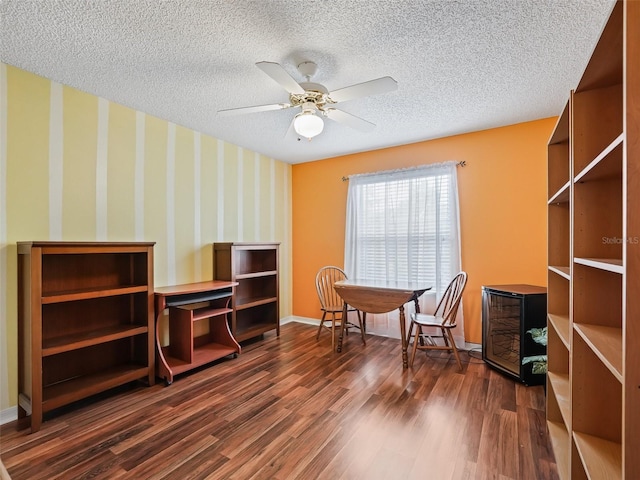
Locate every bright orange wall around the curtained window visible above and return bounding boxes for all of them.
[292,118,556,343]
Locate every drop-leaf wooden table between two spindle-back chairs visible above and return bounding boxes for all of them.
[333,280,431,368]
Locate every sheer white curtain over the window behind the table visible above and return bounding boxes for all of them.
[344,161,465,347]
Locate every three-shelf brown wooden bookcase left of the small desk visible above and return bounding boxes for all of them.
[18,242,155,432]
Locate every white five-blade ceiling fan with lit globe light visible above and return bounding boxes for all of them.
[218,62,398,140]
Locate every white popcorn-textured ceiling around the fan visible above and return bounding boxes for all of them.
[0,0,613,163]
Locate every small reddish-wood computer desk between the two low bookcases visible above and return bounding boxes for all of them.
[155,280,240,385]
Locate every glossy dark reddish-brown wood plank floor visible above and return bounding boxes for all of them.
[0,323,557,480]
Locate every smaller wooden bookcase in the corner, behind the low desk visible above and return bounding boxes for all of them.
[213,242,280,342]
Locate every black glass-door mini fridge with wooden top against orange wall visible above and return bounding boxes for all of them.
[482,285,547,385]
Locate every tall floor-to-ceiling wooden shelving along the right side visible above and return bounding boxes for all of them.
[547,0,640,479]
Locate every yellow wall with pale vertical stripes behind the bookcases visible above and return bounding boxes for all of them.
[0,63,292,411]
